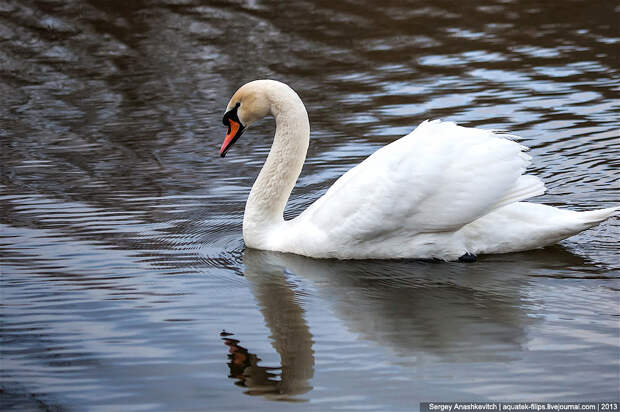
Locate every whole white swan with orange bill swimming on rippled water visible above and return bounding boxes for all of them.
[220,80,620,261]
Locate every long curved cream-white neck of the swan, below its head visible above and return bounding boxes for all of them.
[243,88,310,249]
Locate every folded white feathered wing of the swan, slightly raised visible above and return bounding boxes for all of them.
[299,120,545,242]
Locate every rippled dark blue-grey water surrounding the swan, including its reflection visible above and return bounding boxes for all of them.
[0,0,620,410]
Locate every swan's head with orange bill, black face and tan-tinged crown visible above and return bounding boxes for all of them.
[220,80,277,157]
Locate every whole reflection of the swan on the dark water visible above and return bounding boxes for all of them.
[225,247,587,400]
